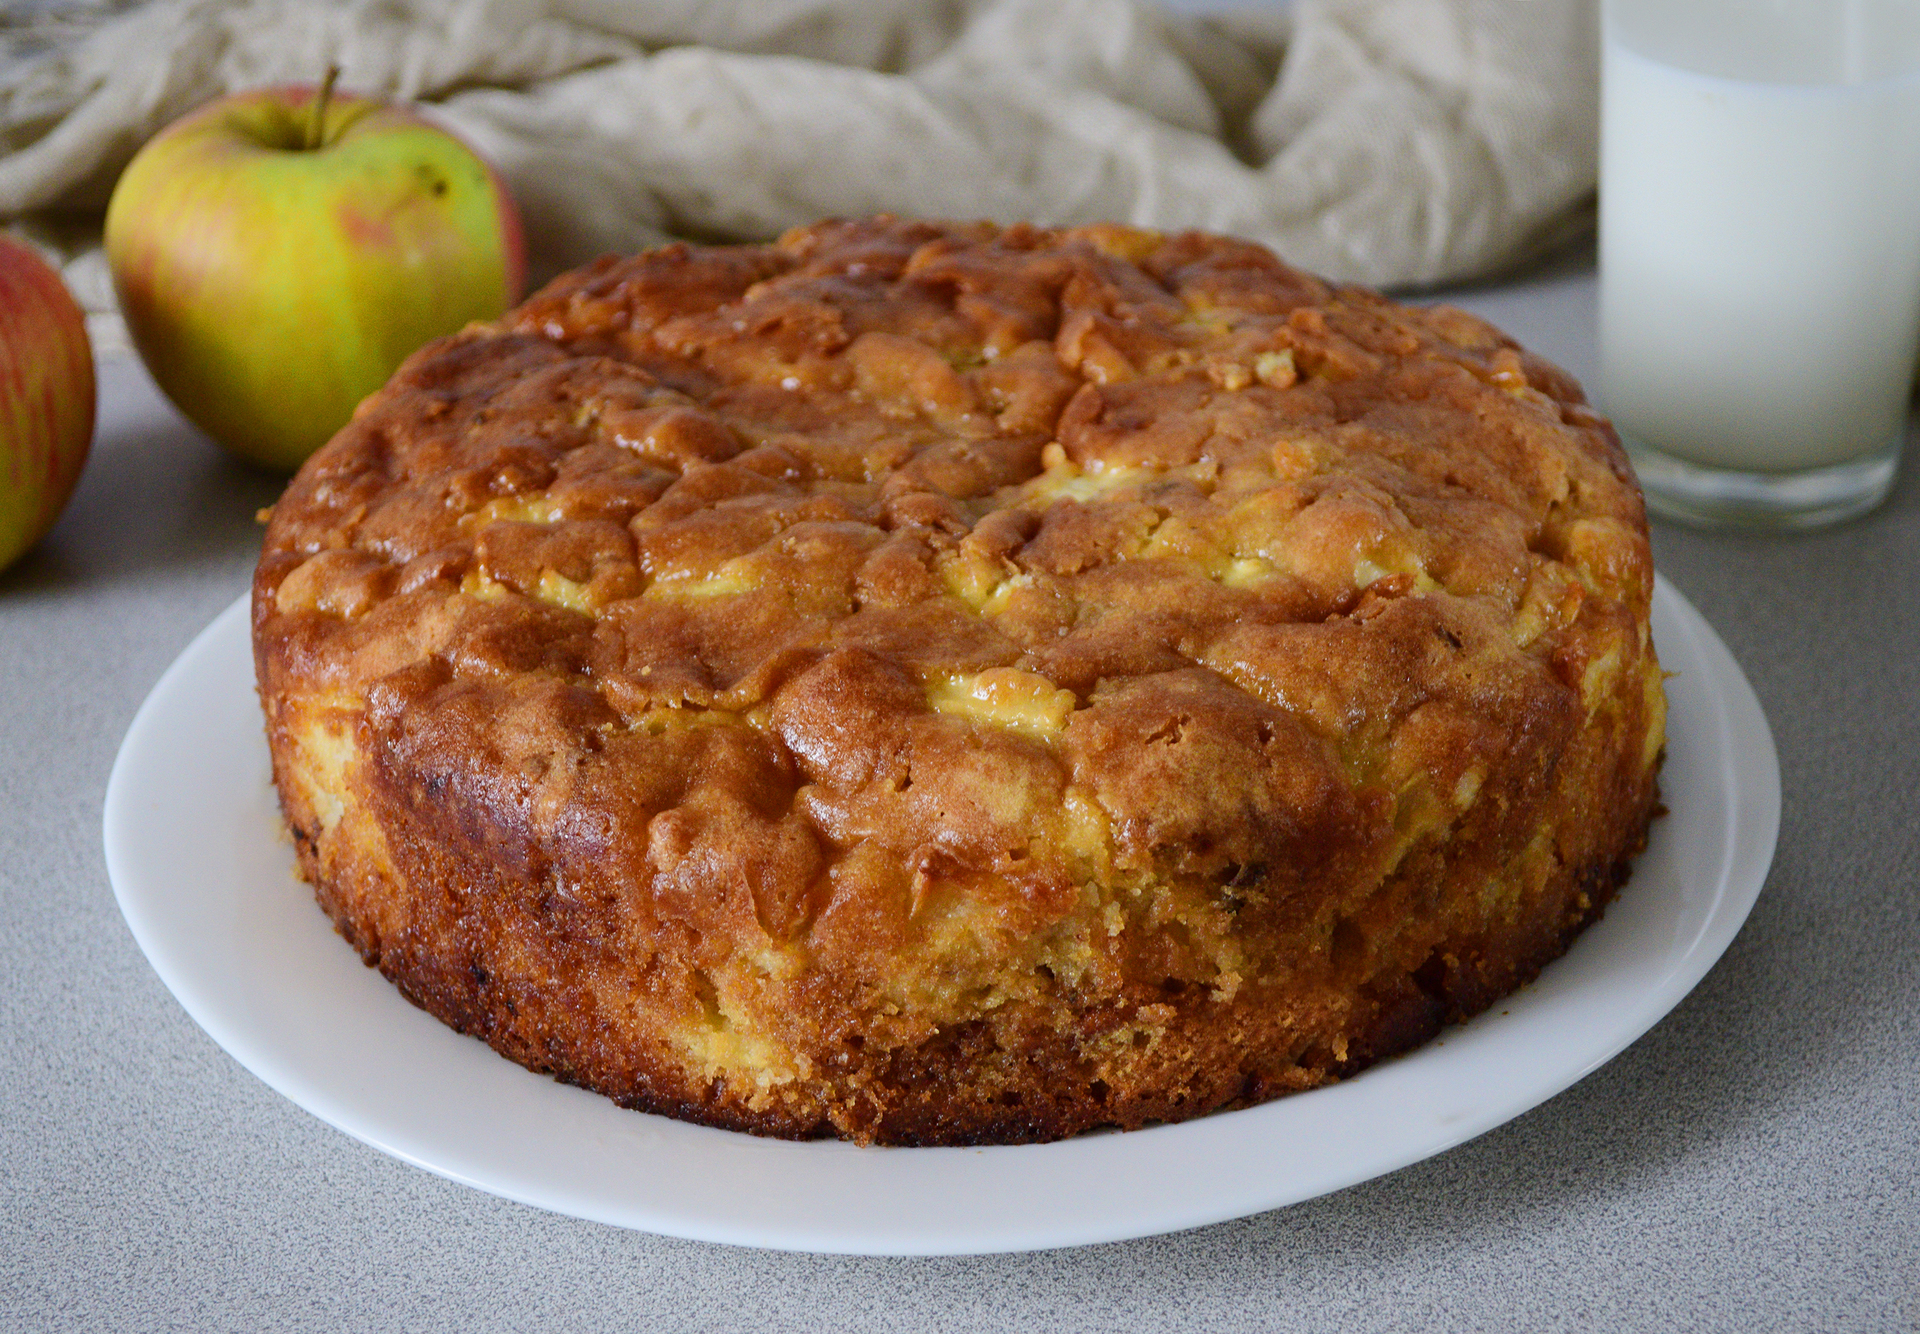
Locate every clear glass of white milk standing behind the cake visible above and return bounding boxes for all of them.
[1599,0,1920,528]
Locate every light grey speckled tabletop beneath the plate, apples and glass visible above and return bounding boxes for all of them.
[0,259,1920,1330]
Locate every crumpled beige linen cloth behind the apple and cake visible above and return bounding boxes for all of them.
[0,0,1597,353]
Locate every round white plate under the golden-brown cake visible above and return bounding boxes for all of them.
[106,580,1780,1255]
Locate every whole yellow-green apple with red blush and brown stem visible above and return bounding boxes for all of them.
[106,88,526,470]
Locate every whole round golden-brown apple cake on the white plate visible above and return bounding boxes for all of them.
[253,219,1665,1144]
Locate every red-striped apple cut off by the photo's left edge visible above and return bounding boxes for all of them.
[0,234,94,570]
